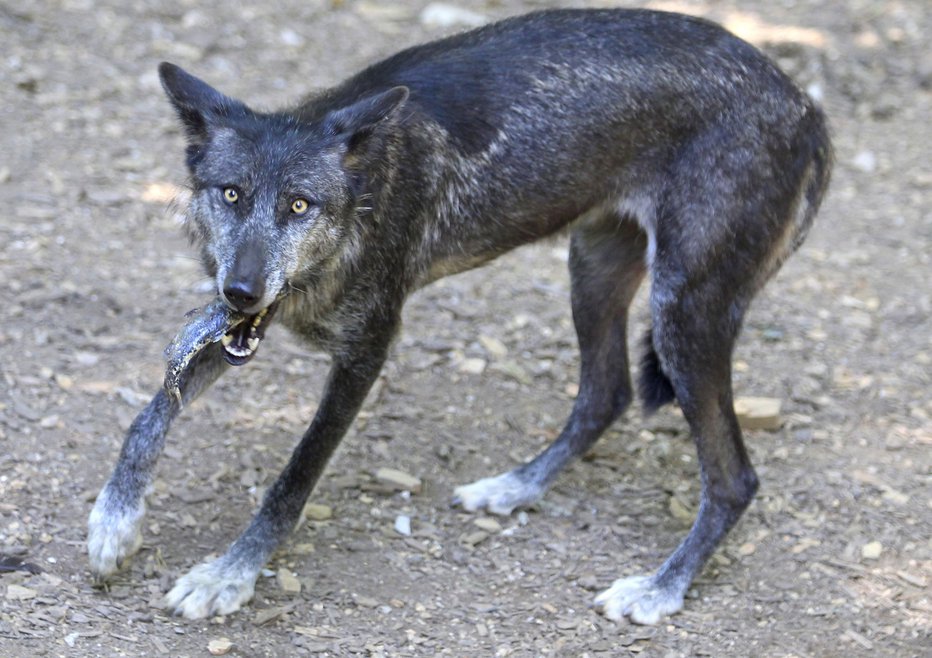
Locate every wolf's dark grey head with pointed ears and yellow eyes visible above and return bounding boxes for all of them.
[159,63,408,315]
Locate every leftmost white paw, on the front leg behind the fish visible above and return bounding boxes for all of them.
[87,486,146,580]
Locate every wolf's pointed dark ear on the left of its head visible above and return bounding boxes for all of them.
[159,62,246,143]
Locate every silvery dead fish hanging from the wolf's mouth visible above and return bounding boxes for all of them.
[164,296,247,405]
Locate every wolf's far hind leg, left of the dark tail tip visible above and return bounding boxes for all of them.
[454,214,647,514]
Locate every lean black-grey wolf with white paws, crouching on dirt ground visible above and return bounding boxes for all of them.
[88,9,832,624]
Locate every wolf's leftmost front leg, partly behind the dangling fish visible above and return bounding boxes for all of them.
[87,345,226,582]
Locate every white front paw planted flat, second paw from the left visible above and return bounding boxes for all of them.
[165,558,259,619]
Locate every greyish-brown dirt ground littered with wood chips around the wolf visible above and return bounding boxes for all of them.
[0,0,932,656]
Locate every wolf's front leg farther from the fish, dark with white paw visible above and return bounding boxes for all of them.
[165,328,393,619]
